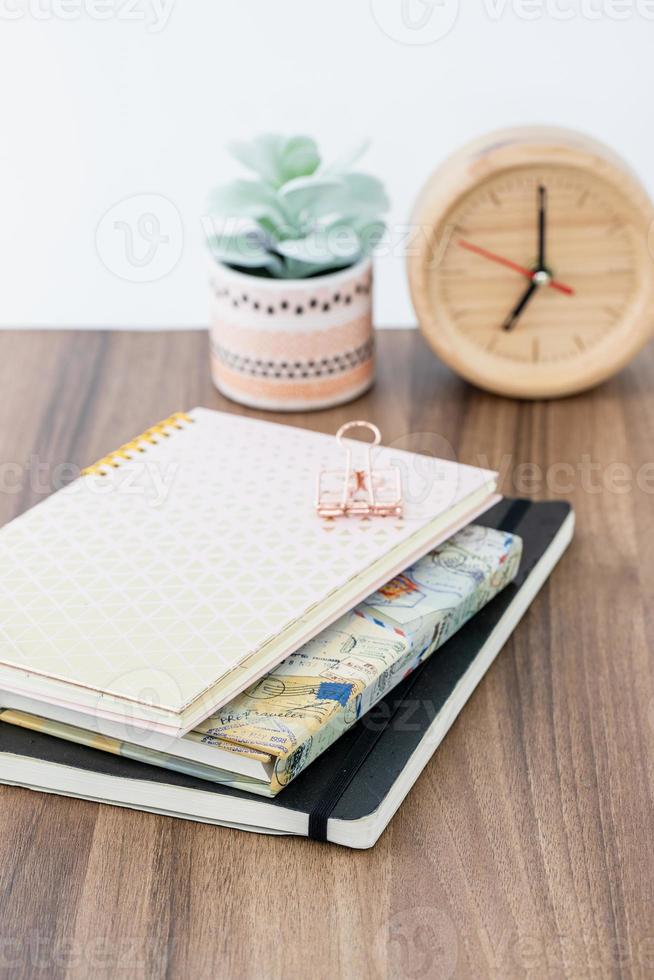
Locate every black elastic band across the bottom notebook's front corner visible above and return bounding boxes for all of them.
[307,660,427,841]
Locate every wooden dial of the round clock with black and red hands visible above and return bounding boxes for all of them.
[432,167,639,363]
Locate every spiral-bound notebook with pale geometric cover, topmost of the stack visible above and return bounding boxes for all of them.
[0,408,496,735]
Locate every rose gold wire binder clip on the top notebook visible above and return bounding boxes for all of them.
[316,421,403,517]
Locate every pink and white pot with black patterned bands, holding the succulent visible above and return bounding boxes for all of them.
[210,259,374,412]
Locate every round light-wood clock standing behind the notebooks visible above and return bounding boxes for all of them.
[408,127,654,398]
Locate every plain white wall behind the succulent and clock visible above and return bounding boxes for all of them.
[0,0,654,327]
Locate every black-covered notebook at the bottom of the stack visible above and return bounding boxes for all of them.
[0,499,574,847]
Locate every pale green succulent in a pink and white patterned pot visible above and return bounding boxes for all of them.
[205,134,388,411]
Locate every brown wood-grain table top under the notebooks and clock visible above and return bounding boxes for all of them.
[0,331,654,980]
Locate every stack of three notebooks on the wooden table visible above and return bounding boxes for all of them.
[0,409,572,847]
